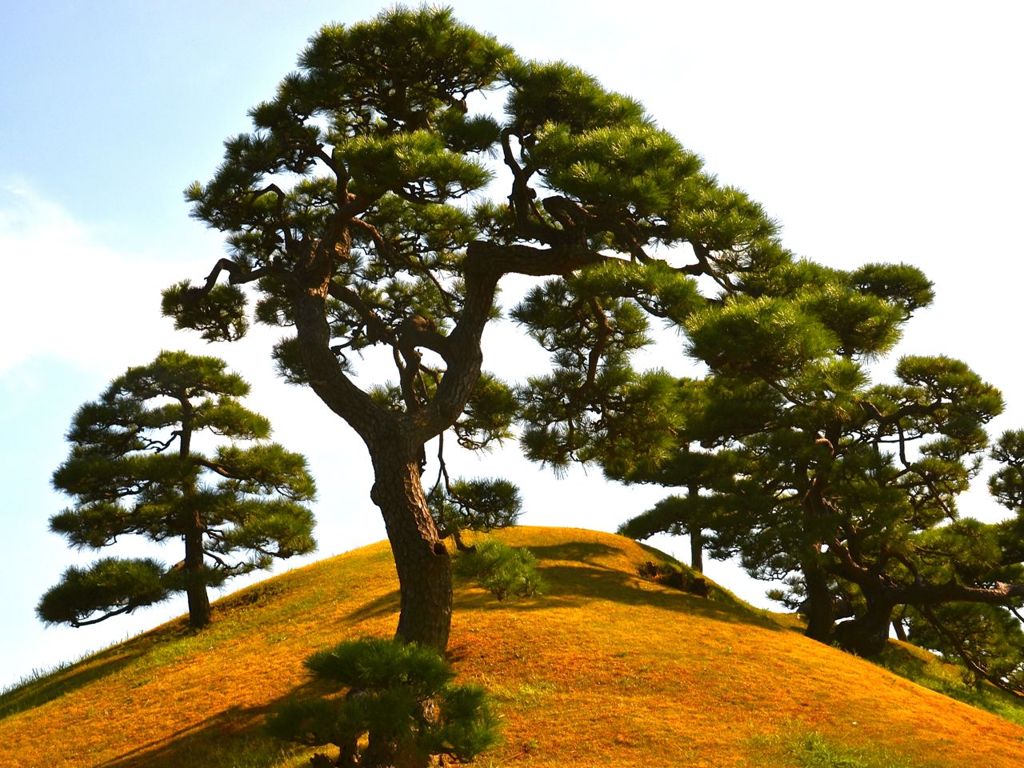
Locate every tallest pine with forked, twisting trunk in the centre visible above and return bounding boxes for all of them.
[164,8,788,649]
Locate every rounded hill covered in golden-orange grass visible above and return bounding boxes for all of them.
[0,527,1024,768]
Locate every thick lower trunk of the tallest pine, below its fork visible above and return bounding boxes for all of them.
[370,440,452,653]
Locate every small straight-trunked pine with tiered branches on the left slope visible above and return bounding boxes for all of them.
[37,352,315,628]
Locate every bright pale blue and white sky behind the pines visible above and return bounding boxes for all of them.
[0,0,1024,689]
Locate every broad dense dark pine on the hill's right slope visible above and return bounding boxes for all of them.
[624,263,1024,655]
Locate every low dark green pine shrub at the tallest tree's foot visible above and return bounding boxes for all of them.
[267,638,498,768]
